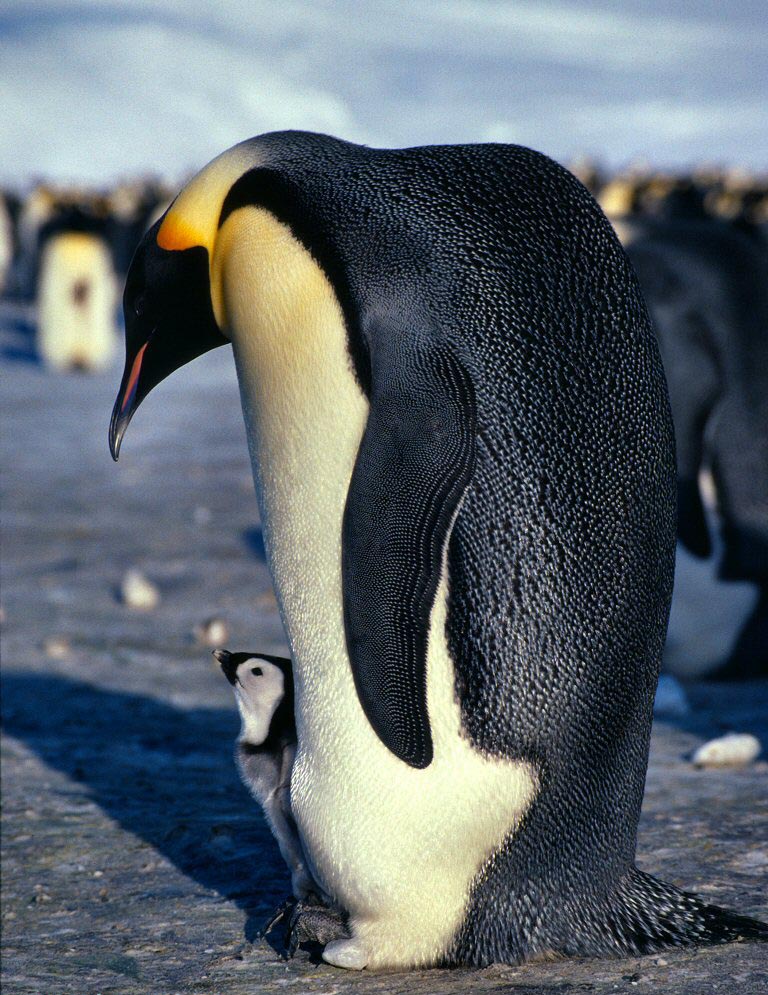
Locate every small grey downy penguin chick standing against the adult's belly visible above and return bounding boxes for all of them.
[213,649,322,899]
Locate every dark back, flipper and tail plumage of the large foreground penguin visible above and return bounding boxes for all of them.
[114,132,765,964]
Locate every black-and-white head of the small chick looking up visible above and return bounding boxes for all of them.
[214,650,285,746]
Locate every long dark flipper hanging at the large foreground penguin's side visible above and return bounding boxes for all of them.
[342,334,475,768]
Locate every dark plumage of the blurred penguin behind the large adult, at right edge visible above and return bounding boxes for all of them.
[617,219,768,678]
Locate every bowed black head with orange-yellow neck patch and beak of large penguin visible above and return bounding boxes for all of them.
[109,142,255,460]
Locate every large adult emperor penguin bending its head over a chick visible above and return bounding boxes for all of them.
[109,132,768,968]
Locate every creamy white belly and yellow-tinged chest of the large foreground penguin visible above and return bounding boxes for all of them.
[222,209,535,967]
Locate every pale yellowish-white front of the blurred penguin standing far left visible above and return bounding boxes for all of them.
[37,231,117,370]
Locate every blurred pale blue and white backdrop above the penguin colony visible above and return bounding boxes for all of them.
[0,0,768,184]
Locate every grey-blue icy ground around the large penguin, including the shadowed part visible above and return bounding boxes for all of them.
[0,307,768,995]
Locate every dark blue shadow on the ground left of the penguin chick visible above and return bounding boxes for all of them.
[2,673,290,952]
